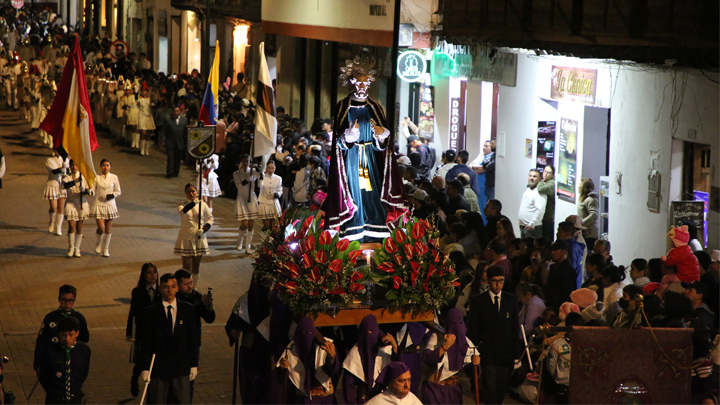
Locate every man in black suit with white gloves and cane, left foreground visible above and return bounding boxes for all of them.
[140,273,198,404]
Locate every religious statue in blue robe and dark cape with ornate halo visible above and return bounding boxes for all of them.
[325,56,406,242]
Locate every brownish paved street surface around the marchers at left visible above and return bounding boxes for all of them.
[0,103,253,404]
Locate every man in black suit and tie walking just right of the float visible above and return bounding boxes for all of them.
[468,266,522,404]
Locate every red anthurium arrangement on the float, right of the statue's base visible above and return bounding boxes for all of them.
[370,218,457,313]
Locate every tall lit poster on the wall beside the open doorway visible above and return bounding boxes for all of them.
[555,118,578,204]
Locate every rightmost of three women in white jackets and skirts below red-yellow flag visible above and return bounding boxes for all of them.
[90,159,121,257]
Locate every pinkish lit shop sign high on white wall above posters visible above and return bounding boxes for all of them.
[550,66,597,105]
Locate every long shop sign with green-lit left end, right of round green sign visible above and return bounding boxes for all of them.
[433,42,517,87]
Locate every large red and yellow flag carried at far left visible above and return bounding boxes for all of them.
[40,36,98,187]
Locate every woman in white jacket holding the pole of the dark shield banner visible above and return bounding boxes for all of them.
[175,183,214,288]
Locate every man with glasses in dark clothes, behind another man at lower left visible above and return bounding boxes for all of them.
[33,284,90,372]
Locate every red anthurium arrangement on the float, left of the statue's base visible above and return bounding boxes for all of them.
[273,218,367,316]
